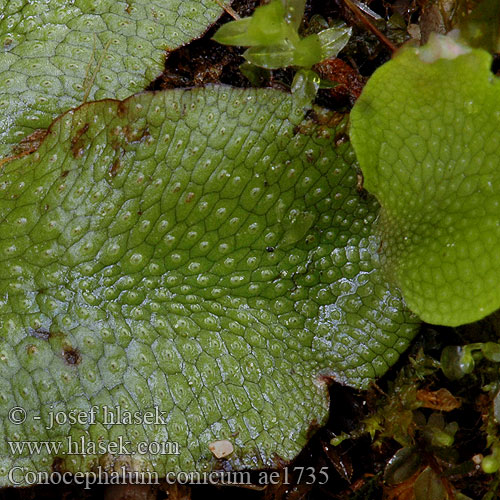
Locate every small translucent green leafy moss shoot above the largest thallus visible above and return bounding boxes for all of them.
[213,0,351,100]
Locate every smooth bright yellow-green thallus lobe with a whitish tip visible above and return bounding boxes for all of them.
[350,37,500,326]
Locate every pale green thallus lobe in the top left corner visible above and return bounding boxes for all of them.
[0,0,227,157]
